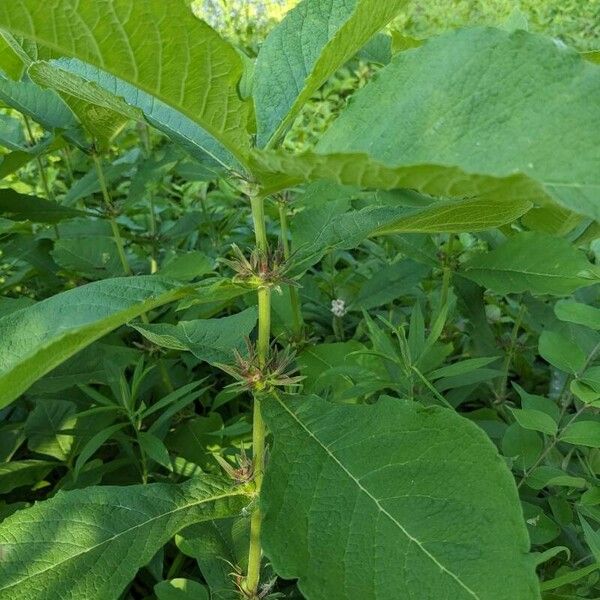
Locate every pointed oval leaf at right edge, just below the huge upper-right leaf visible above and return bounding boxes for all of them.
[461,232,600,296]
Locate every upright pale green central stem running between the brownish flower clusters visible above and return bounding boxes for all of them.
[244,195,271,599]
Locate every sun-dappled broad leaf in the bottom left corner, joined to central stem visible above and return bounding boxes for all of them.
[0,476,248,600]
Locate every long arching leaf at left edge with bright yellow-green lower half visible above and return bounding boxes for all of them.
[0,276,187,407]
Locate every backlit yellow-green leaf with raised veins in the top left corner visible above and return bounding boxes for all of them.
[0,0,249,169]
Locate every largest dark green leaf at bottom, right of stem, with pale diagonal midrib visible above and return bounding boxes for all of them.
[261,396,540,600]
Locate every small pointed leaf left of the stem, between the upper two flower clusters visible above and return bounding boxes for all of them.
[135,308,257,363]
